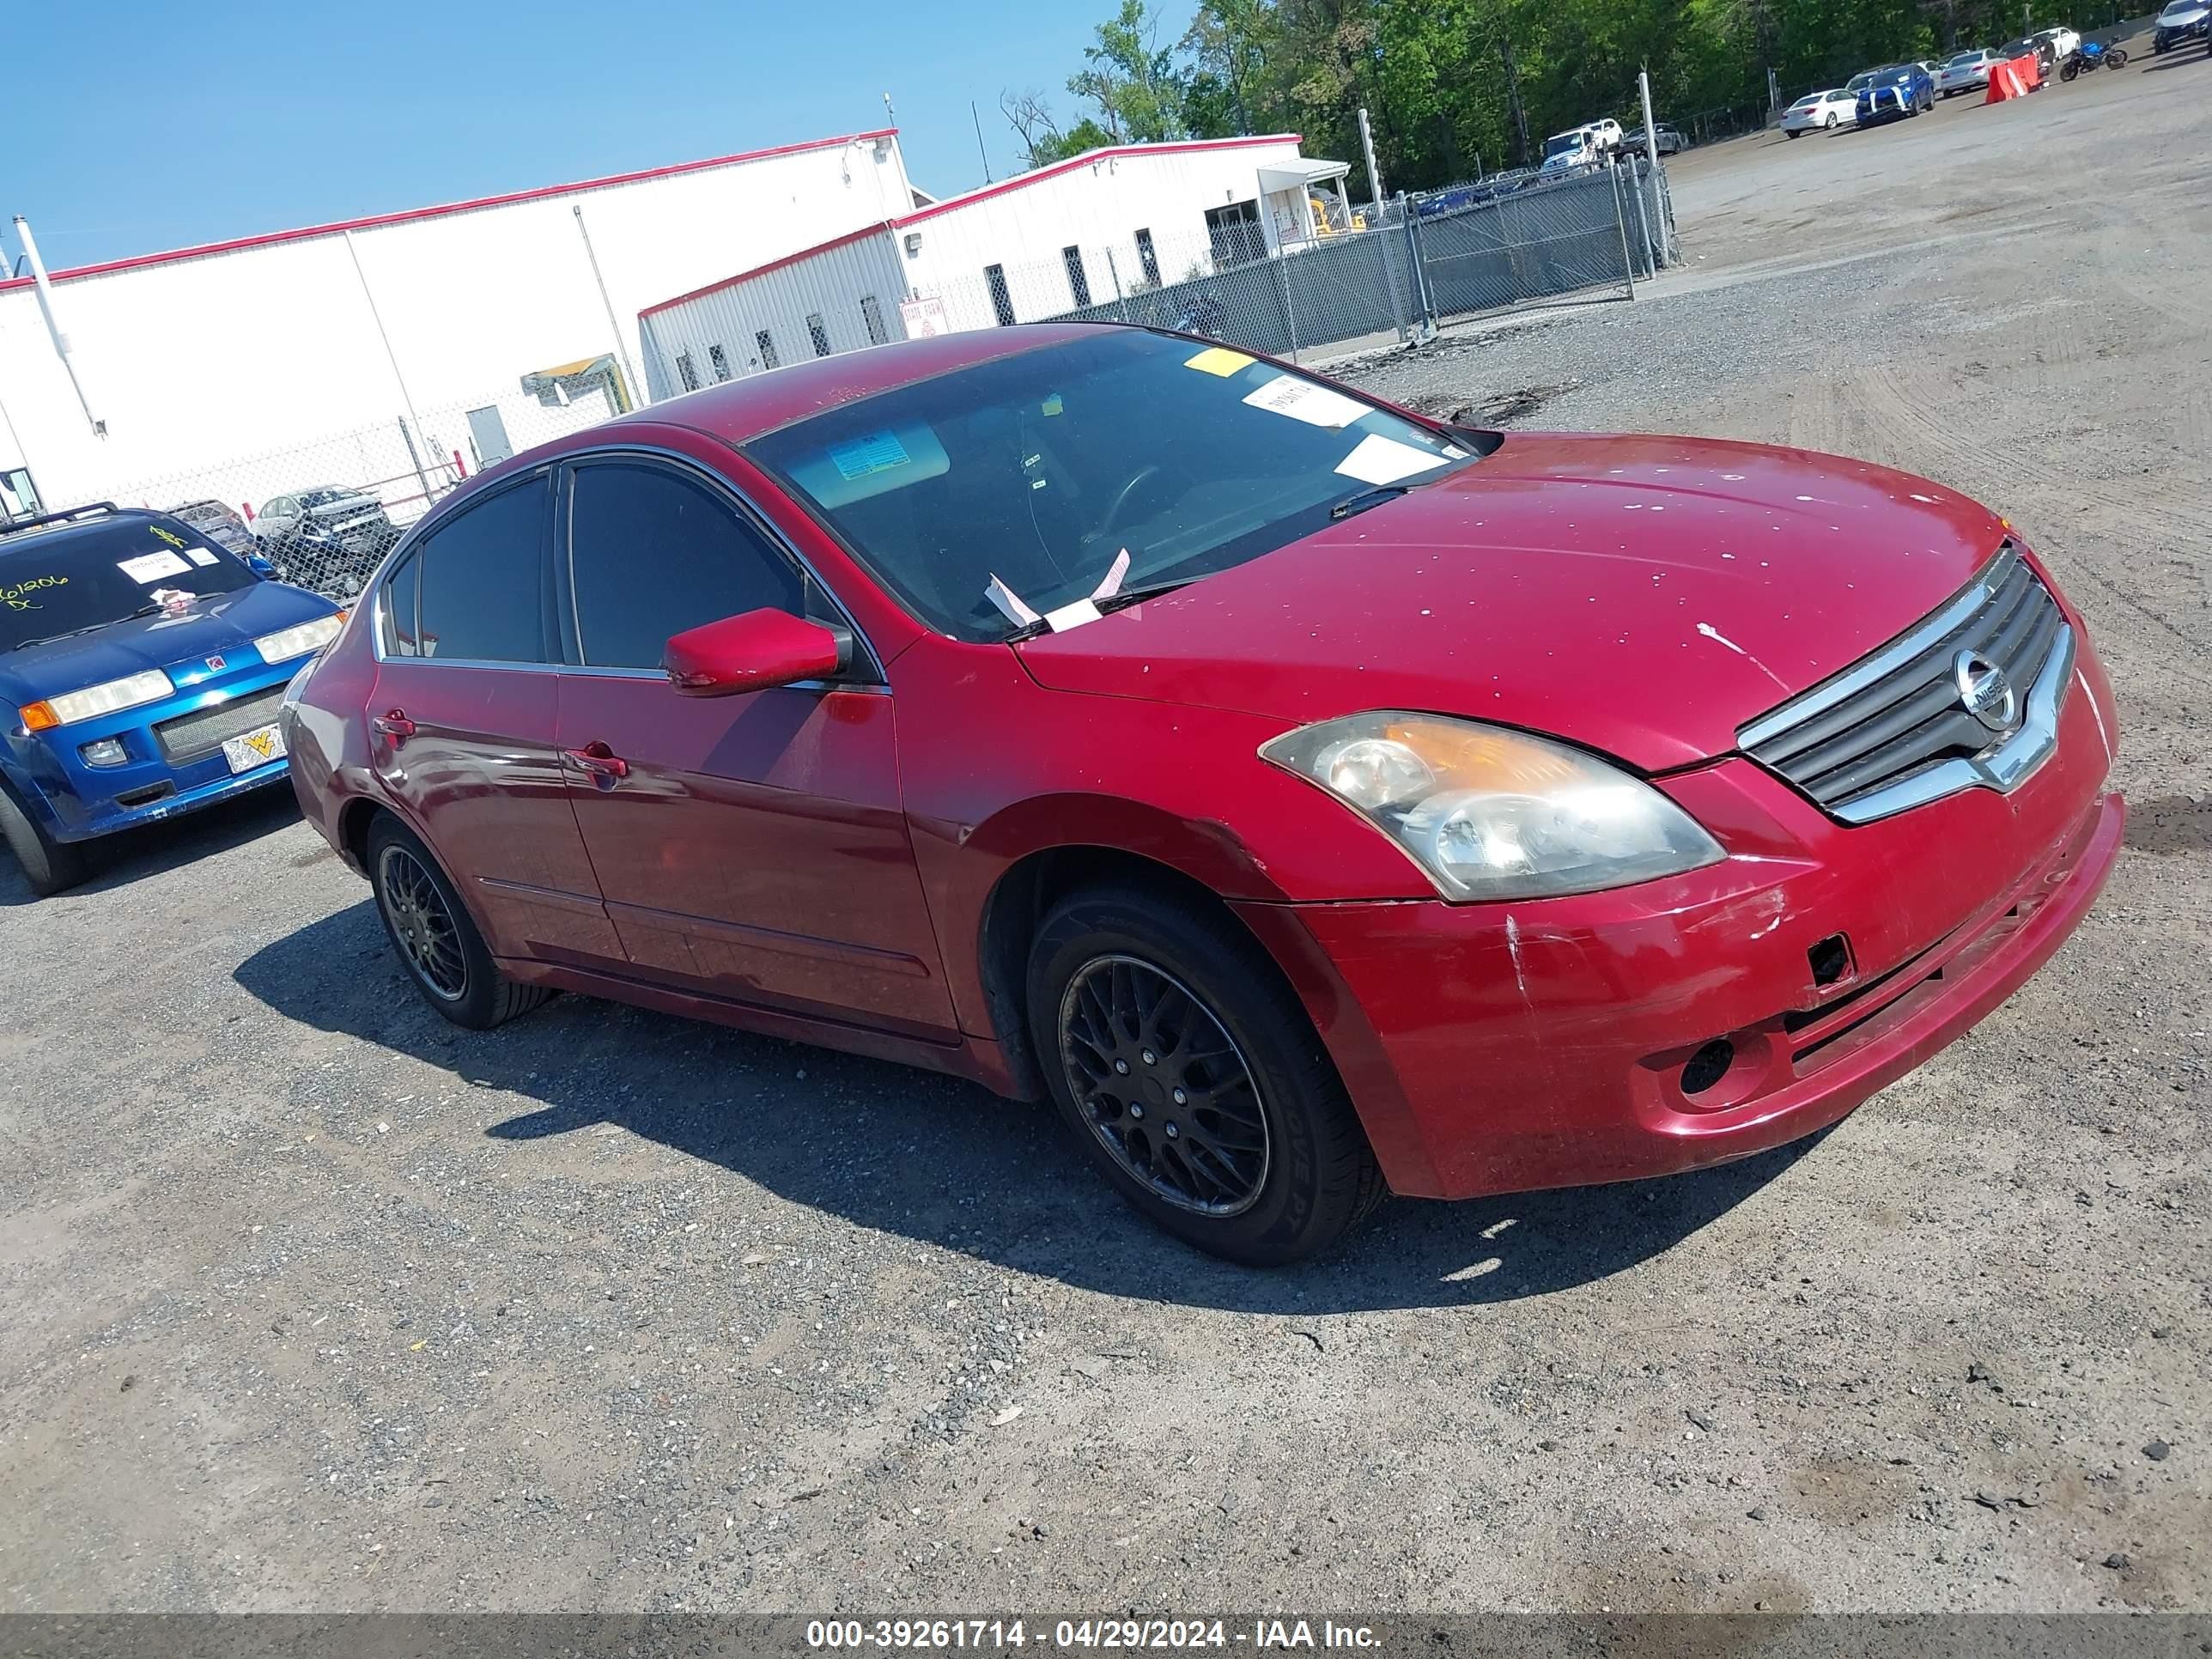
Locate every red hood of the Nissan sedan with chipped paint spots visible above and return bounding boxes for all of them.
[1015,434,2004,772]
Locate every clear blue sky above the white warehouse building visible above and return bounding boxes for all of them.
[0,0,1141,268]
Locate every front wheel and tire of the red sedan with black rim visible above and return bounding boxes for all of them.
[1029,884,1387,1267]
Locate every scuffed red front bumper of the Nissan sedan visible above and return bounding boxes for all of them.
[1239,641,2126,1199]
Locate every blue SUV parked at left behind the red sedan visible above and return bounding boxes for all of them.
[0,502,345,896]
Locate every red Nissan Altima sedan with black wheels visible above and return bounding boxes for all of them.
[285,325,2124,1263]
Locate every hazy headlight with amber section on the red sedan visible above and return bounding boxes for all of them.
[1259,710,1723,900]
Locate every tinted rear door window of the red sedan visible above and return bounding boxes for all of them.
[411,477,553,664]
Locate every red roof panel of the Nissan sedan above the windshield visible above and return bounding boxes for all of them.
[597,323,1128,444]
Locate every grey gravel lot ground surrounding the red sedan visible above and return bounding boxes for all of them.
[0,51,2212,1613]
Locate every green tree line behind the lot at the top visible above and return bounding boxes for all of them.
[1000,0,2135,195]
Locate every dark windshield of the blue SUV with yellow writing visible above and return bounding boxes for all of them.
[0,518,254,653]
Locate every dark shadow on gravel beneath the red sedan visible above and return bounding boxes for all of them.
[234,900,1814,1314]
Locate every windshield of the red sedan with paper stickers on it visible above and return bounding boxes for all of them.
[745,330,1486,639]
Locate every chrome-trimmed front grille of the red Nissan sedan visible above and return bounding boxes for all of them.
[1736,542,2075,823]
